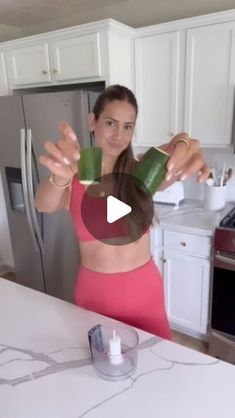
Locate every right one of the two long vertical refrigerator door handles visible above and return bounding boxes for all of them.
[26,129,45,252]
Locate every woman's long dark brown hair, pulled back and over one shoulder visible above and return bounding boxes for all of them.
[93,84,153,242]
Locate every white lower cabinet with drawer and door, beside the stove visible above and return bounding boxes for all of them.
[152,228,211,337]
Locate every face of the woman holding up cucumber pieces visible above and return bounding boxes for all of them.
[89,100,136,158]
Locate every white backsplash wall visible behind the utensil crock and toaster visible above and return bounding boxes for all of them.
[134,147,235,202]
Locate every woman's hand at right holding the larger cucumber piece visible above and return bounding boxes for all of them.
[159,133,210,187]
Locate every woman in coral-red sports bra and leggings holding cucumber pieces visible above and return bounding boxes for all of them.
[35,85,209,339]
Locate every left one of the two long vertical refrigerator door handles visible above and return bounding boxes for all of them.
[20,129,39,252]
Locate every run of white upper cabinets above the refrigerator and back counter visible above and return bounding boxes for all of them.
[0,10,235,147]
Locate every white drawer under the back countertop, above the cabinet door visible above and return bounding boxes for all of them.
[163,230,211,257]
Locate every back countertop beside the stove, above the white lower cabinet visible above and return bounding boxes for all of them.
[154,199,235,236]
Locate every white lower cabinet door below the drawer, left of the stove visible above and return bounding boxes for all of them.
[163,251,210,334]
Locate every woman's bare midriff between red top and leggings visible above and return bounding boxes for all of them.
[80,233,151,273]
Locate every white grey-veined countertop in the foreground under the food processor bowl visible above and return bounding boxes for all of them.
[0,279,235,418]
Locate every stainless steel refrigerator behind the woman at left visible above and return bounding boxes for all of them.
[0,91,98,301]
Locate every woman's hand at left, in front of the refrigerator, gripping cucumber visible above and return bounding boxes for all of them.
[39,122,80,183]
